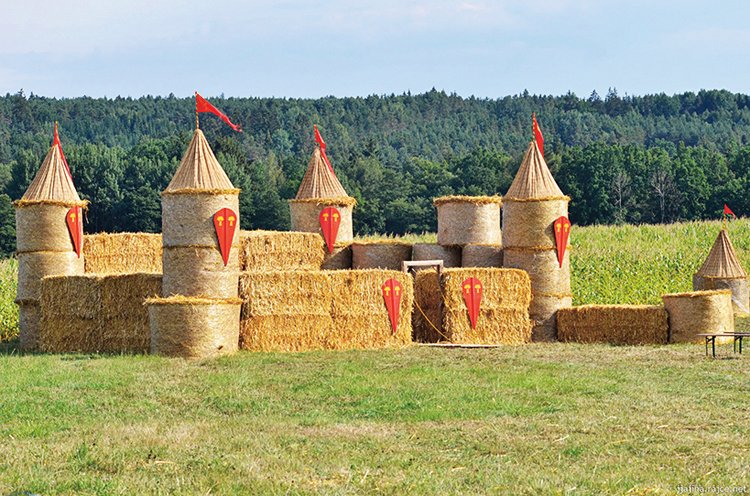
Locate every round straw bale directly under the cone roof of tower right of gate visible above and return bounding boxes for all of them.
[503,199,568,248]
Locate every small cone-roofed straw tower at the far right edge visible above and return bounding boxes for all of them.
[693,229,750,315]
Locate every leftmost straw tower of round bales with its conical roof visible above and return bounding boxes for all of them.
[14,134,87,350]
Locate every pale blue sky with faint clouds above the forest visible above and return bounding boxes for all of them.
[0,0,750,98]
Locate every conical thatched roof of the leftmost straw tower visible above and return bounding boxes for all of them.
[21,144,81,203]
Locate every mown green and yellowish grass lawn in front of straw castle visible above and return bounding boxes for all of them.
[0,344,750,495]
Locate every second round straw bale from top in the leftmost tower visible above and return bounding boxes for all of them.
[18,251,84,300]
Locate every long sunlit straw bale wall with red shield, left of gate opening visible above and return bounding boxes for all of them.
[240,270,413,351]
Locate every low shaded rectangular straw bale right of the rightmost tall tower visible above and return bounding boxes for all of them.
[557,305,669,345]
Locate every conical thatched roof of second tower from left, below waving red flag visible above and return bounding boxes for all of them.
[164,129,234,193]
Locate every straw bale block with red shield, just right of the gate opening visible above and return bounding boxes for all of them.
[441,268,531,344]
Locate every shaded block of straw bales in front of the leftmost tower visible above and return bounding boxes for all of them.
[39,273,161,353]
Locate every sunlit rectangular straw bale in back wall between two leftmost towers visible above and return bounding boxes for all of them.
[83,233,162,274]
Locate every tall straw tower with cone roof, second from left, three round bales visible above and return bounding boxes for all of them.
[147,129,241,358]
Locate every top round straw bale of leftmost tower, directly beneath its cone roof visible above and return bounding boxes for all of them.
[16,203,73,253]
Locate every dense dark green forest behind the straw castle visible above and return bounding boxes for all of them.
[0,86,750,254]
